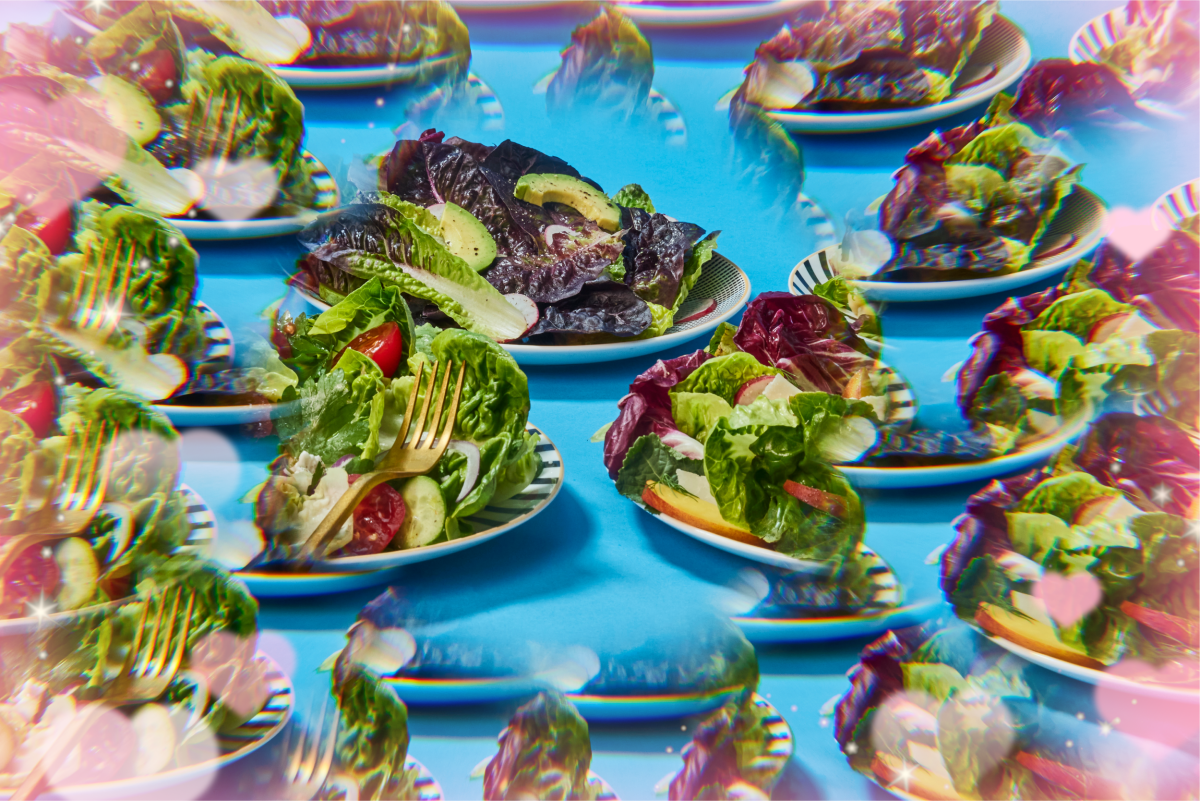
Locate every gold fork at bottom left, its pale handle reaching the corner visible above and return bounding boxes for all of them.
[8,588,196,801]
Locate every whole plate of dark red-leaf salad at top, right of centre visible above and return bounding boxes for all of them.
[730,0,1032,133]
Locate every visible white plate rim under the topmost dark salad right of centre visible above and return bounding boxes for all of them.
[767,16,1033,133]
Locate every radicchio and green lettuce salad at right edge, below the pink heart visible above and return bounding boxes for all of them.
[958,231,1200,446]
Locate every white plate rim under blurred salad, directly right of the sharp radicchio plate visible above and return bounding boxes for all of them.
[839,418,1087,489]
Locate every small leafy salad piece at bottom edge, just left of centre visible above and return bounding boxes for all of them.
[484,692,602,801]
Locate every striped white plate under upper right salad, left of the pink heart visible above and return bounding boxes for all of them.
[787,186,1105,302]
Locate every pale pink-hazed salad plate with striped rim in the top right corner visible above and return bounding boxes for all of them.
[1067,0,1200,116]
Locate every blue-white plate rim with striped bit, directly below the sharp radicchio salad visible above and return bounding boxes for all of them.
[732,544,943,643]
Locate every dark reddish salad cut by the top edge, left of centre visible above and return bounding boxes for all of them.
[258,0,470,78]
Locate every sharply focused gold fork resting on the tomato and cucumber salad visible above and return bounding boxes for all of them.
[299,362,467,561]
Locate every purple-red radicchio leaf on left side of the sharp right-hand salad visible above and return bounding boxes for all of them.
[604,350,712,481]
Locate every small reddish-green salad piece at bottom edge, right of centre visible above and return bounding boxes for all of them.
[667,682,792,801]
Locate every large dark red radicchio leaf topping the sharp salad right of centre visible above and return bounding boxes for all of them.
[733,293,874,395]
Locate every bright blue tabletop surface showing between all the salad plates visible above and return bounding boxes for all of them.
[7,0,1200,801]
